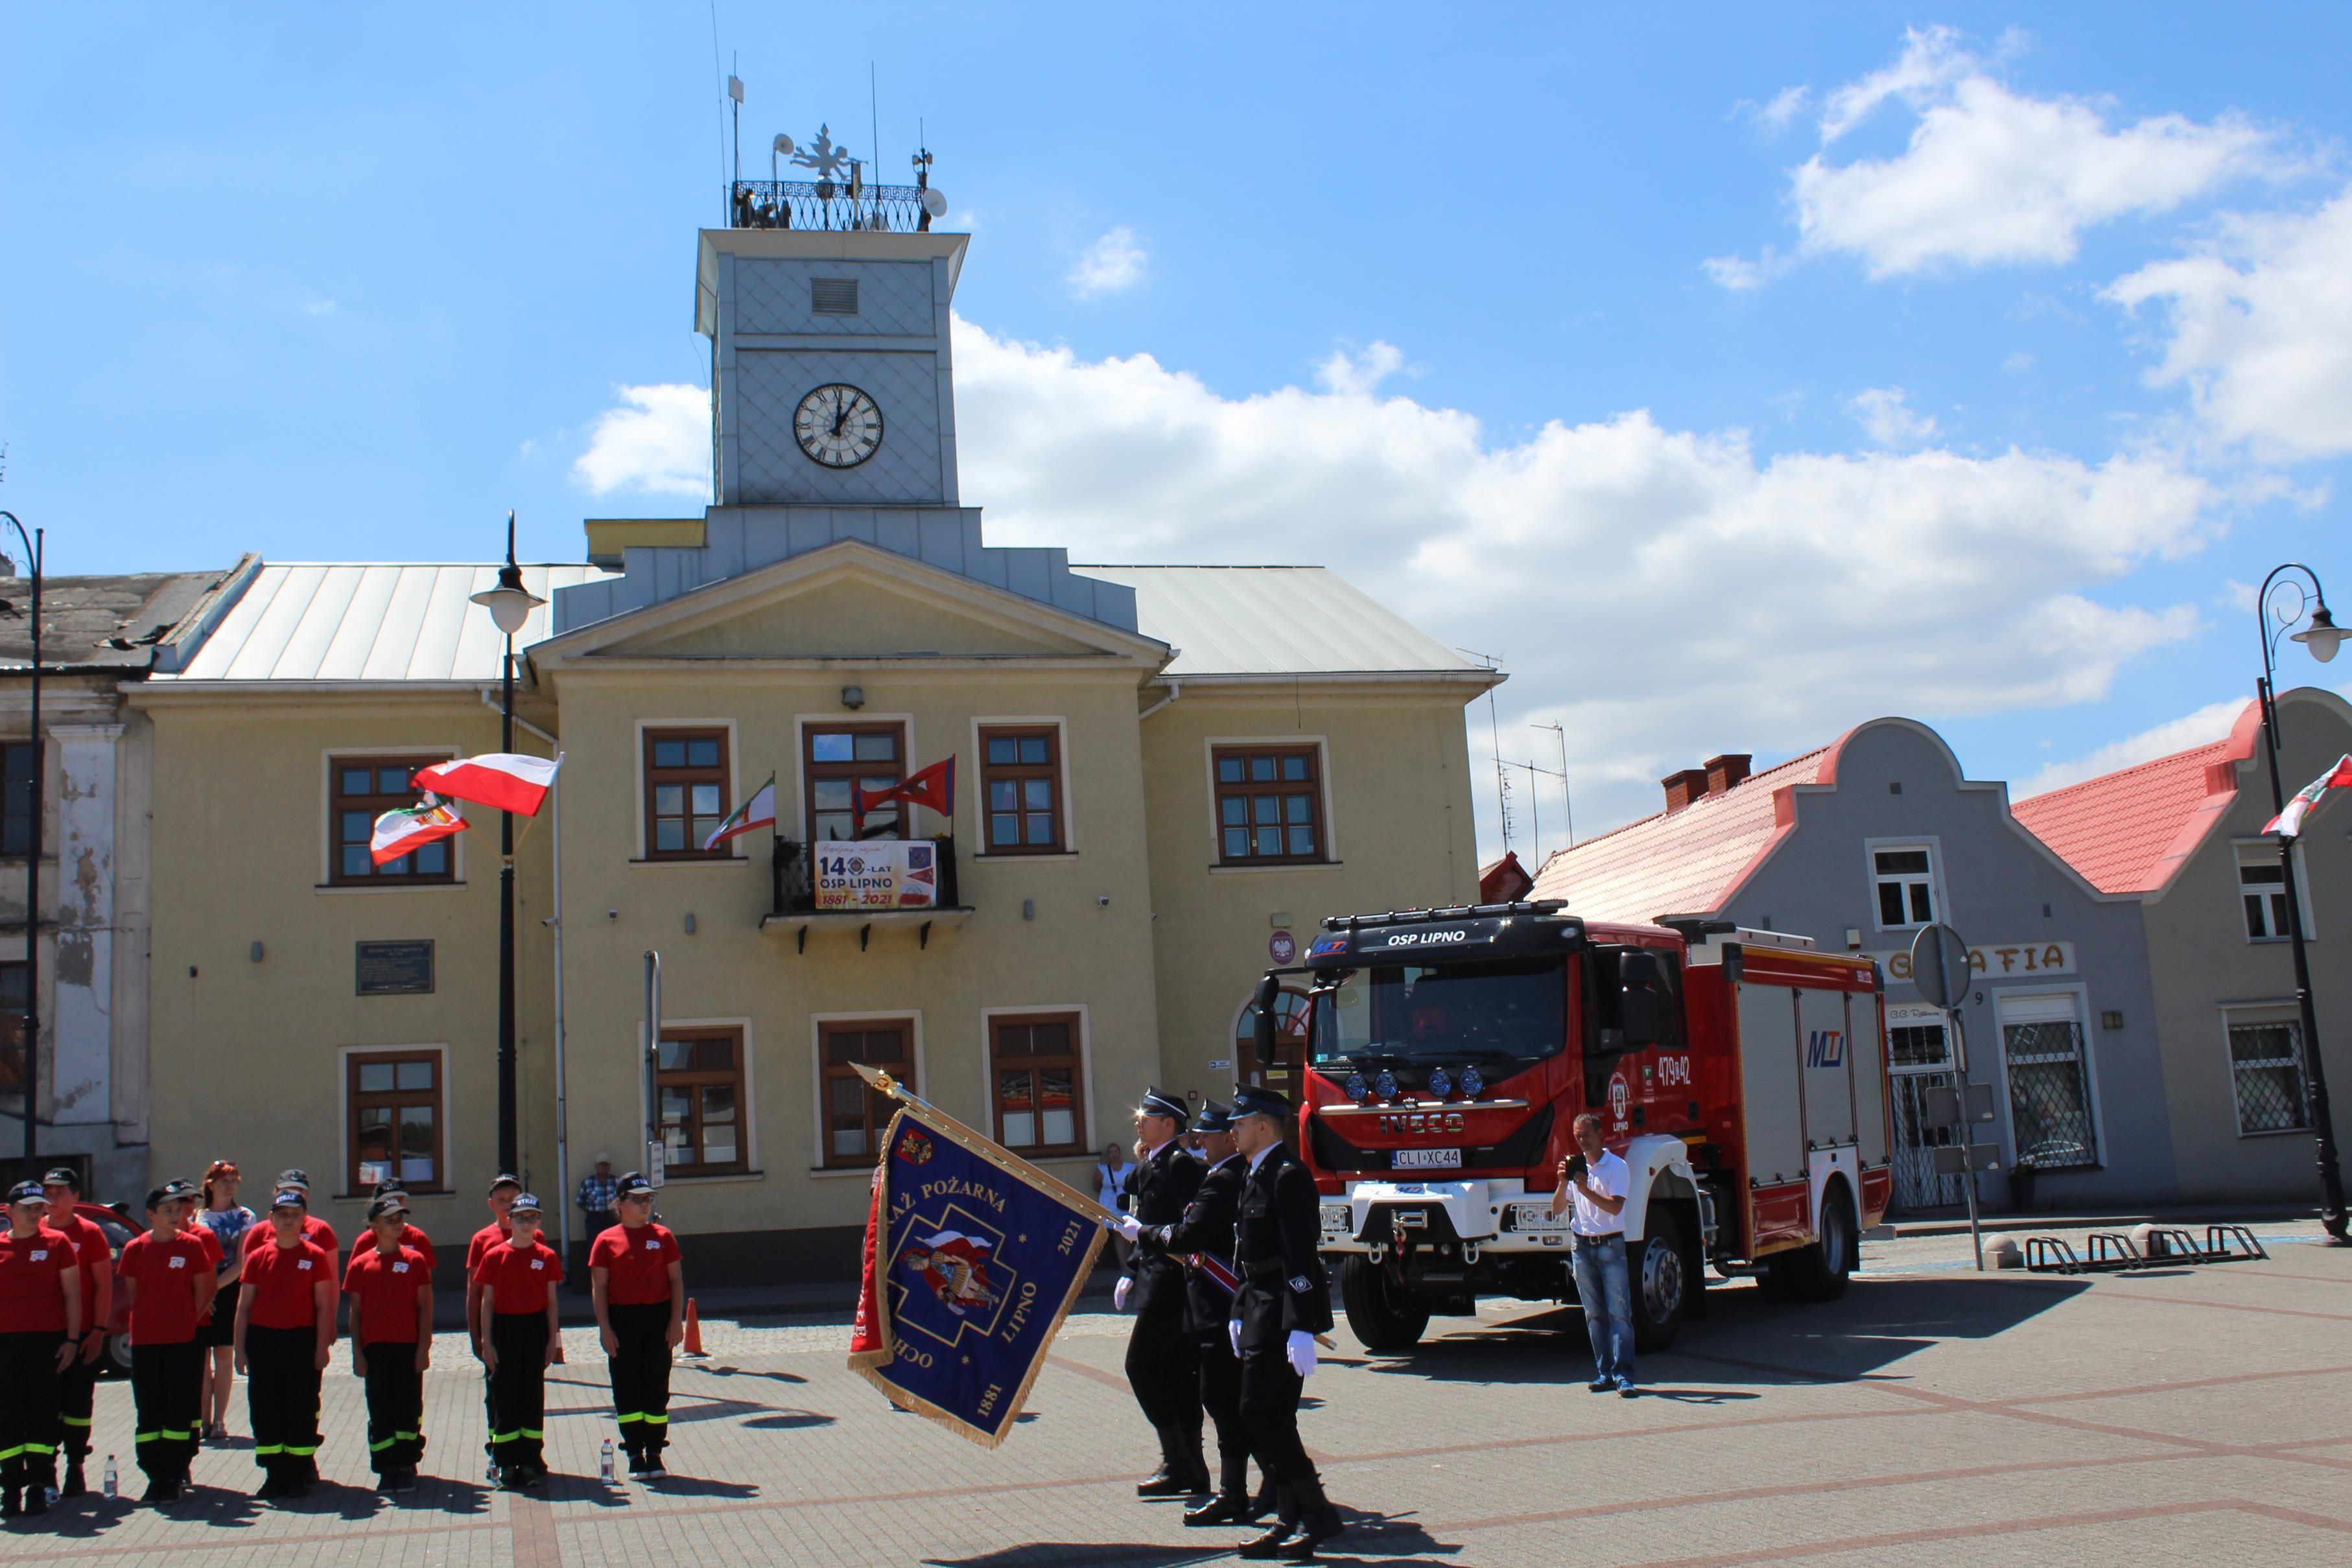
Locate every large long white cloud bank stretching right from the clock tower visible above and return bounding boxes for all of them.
[955,322,2222,830]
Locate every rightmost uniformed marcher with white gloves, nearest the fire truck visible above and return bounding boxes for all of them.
[1230,1086,1343,1563]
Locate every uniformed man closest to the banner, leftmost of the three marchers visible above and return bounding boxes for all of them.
[1112,1088,1209,1497]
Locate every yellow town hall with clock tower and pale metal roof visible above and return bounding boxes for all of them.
[127,228,1498,1281]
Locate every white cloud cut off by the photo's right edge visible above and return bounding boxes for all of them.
[2108,188,2352,458]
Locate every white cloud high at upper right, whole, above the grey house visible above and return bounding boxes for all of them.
[1769,29,2300,287]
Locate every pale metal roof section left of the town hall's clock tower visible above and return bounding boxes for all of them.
[155,562,609,684]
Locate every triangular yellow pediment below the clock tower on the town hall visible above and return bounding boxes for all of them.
[534,543,1166,668]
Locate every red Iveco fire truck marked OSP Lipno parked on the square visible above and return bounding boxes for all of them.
[1258,900,1894,1352]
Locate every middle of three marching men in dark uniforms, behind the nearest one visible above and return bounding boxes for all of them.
[1120,1100,1263,1523]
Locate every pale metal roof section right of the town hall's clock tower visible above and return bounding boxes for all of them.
[1070,562,1503,684]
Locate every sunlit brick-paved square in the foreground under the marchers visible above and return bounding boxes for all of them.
[0,1225,2352,1568]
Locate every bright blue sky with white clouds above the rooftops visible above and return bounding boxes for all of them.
[0,3,2352,851]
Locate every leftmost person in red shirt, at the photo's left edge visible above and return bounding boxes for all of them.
[0,1182,82,1519]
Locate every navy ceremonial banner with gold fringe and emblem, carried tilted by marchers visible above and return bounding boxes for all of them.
[849,1074,1108,1448]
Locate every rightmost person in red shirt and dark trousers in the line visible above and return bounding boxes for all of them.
[588,1171,687,1477]
